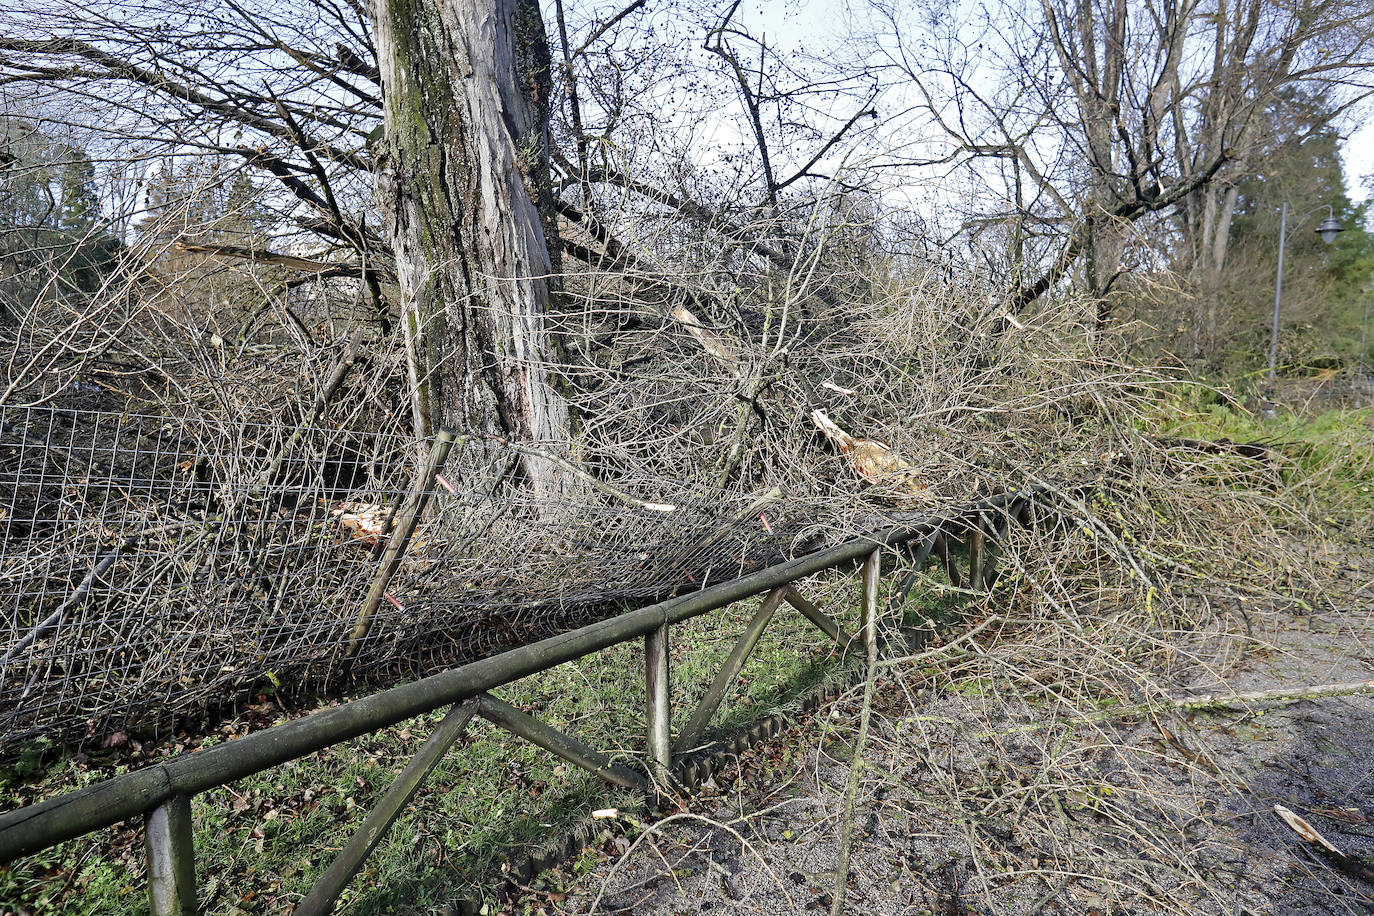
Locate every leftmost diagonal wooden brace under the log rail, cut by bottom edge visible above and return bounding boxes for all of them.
[293,699,477,916]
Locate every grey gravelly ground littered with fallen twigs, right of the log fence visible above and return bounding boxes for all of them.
[508,574,1374,916]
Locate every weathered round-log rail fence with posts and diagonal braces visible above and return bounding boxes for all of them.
[0,472,1052,916]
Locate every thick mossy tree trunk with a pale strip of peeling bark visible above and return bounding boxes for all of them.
[372,0,567,497]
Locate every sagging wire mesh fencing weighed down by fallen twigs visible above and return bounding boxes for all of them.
[0,407,838,759]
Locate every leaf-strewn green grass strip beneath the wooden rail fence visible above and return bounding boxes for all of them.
[0,580,879,916]
